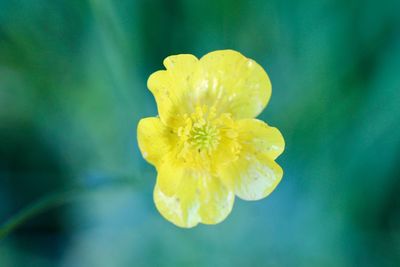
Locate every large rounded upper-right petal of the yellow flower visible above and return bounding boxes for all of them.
[199,50,271,119]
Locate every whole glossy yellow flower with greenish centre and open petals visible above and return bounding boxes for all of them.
[138,50,285,227]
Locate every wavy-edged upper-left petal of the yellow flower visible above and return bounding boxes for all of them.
[147,54,199,126]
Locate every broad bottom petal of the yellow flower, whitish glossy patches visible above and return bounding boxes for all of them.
[154,168,234,227]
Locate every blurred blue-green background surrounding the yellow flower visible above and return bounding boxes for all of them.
[0,0,400,267]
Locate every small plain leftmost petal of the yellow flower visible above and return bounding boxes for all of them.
[137,117,177,166]
